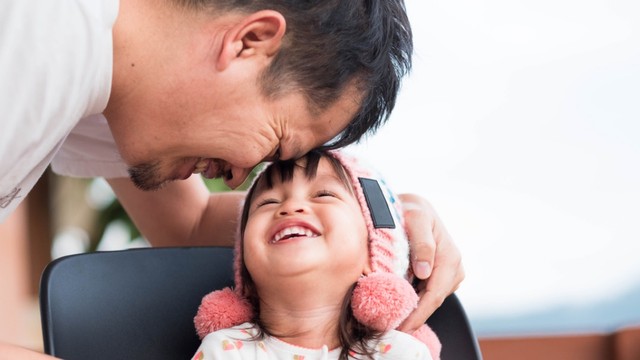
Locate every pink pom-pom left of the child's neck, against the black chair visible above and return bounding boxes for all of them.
[193,288,253,339]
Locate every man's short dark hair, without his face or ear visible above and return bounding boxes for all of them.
[180,0,413,147]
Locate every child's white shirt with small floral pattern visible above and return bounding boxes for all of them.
[192,323,431,360]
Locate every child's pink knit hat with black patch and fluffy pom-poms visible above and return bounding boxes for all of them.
[194,151,440,358]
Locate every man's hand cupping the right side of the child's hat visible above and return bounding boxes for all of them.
[398,194,464,333]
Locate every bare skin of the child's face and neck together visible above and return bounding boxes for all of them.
[243,159,371,348]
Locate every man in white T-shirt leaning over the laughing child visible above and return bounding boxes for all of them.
[0,0,464,356]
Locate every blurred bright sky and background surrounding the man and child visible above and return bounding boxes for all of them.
[0,0,640,359]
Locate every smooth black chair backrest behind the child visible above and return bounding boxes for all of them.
[40,247,480,360]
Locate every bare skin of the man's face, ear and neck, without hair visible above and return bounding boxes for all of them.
[104,1,361,190]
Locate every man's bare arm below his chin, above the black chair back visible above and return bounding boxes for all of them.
[107,175,245,246]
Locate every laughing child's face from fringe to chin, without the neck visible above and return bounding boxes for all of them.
[244,158,370,288]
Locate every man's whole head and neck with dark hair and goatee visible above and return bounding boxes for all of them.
[105,0,413,189]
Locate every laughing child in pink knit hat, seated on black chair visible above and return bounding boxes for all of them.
[193,151,440,360]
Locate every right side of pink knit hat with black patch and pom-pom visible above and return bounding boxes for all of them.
[331,152,418,331]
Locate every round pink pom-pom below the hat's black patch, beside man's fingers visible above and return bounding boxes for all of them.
[351,273,418,331]
